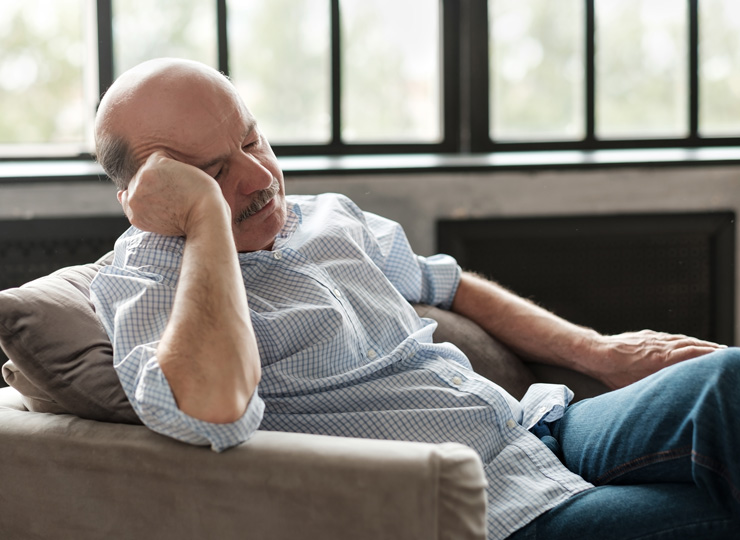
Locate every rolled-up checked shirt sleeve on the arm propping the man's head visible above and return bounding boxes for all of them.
[91,229,264,452]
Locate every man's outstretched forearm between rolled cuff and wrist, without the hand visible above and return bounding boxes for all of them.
[452,273,598,371]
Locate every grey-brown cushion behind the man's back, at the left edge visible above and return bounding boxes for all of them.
[0,255,141,424]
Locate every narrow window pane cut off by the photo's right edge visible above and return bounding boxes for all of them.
[699,0,740,136]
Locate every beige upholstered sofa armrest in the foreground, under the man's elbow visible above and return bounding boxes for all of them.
[0,388,486,540]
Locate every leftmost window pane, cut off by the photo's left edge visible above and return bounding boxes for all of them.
[0,0,92,148]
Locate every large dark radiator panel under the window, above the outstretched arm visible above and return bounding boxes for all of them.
[437,212,735,344]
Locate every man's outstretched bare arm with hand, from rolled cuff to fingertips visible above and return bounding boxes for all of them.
[452,272,722,388]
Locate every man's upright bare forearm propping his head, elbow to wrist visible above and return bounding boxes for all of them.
[157,209,260,423]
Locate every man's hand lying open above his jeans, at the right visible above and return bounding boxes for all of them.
[588,330,725,388]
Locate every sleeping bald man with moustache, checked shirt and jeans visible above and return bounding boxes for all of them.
[92,60,740,539]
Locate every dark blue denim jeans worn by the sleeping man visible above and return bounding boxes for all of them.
[510,348,740,540]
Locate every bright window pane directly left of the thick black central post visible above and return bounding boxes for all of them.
[340,0,442,143]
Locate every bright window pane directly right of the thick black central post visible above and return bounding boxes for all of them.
[488,0,585,140]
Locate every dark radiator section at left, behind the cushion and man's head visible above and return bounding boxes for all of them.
[0,216,129,376]
